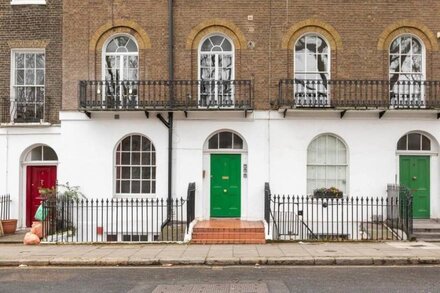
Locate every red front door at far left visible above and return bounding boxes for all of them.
[26,166,57,227]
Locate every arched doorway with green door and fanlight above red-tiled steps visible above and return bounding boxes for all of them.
[204,131,247,218]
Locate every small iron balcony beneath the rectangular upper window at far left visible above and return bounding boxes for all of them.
[0,97,49,123]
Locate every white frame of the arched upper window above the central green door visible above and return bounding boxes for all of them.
[197,32,235,108]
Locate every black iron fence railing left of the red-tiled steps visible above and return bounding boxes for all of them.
[43,198,193,243]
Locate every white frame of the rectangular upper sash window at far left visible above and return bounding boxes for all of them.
[9,48,47,123]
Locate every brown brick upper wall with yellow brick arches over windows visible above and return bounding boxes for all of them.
[63,0,440,110]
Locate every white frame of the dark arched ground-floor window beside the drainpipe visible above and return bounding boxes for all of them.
[113,133,158,198]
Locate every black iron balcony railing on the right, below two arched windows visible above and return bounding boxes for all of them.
[278,79,440,109]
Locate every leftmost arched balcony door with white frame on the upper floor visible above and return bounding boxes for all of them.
[102,35,139,109]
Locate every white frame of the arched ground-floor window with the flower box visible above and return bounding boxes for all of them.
[306,133,350,196]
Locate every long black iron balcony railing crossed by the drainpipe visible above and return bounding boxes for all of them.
[79,80,253,111]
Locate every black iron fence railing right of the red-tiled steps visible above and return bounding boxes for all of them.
[266,192,412,241]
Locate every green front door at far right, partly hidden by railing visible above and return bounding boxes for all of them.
[400,156,430,219]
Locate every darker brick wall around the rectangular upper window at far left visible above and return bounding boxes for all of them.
[0,0,62,123]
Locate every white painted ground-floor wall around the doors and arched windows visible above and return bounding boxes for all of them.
[0,111,440,227]
